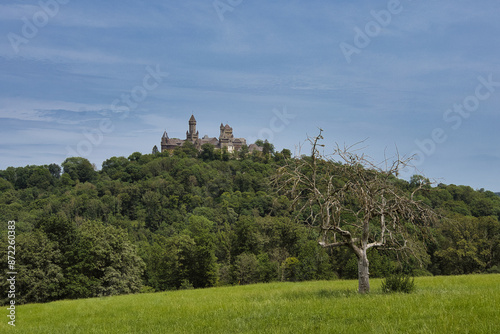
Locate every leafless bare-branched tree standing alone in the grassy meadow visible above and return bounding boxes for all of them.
[274,130,434,293]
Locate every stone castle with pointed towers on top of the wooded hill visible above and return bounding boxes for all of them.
[155,115,260,152]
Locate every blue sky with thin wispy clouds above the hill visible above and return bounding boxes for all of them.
[0,0,500,192]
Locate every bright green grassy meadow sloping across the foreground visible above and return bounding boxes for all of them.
[0,275,500,334]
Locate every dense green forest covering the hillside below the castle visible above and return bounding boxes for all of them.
[0,143,500,302]
